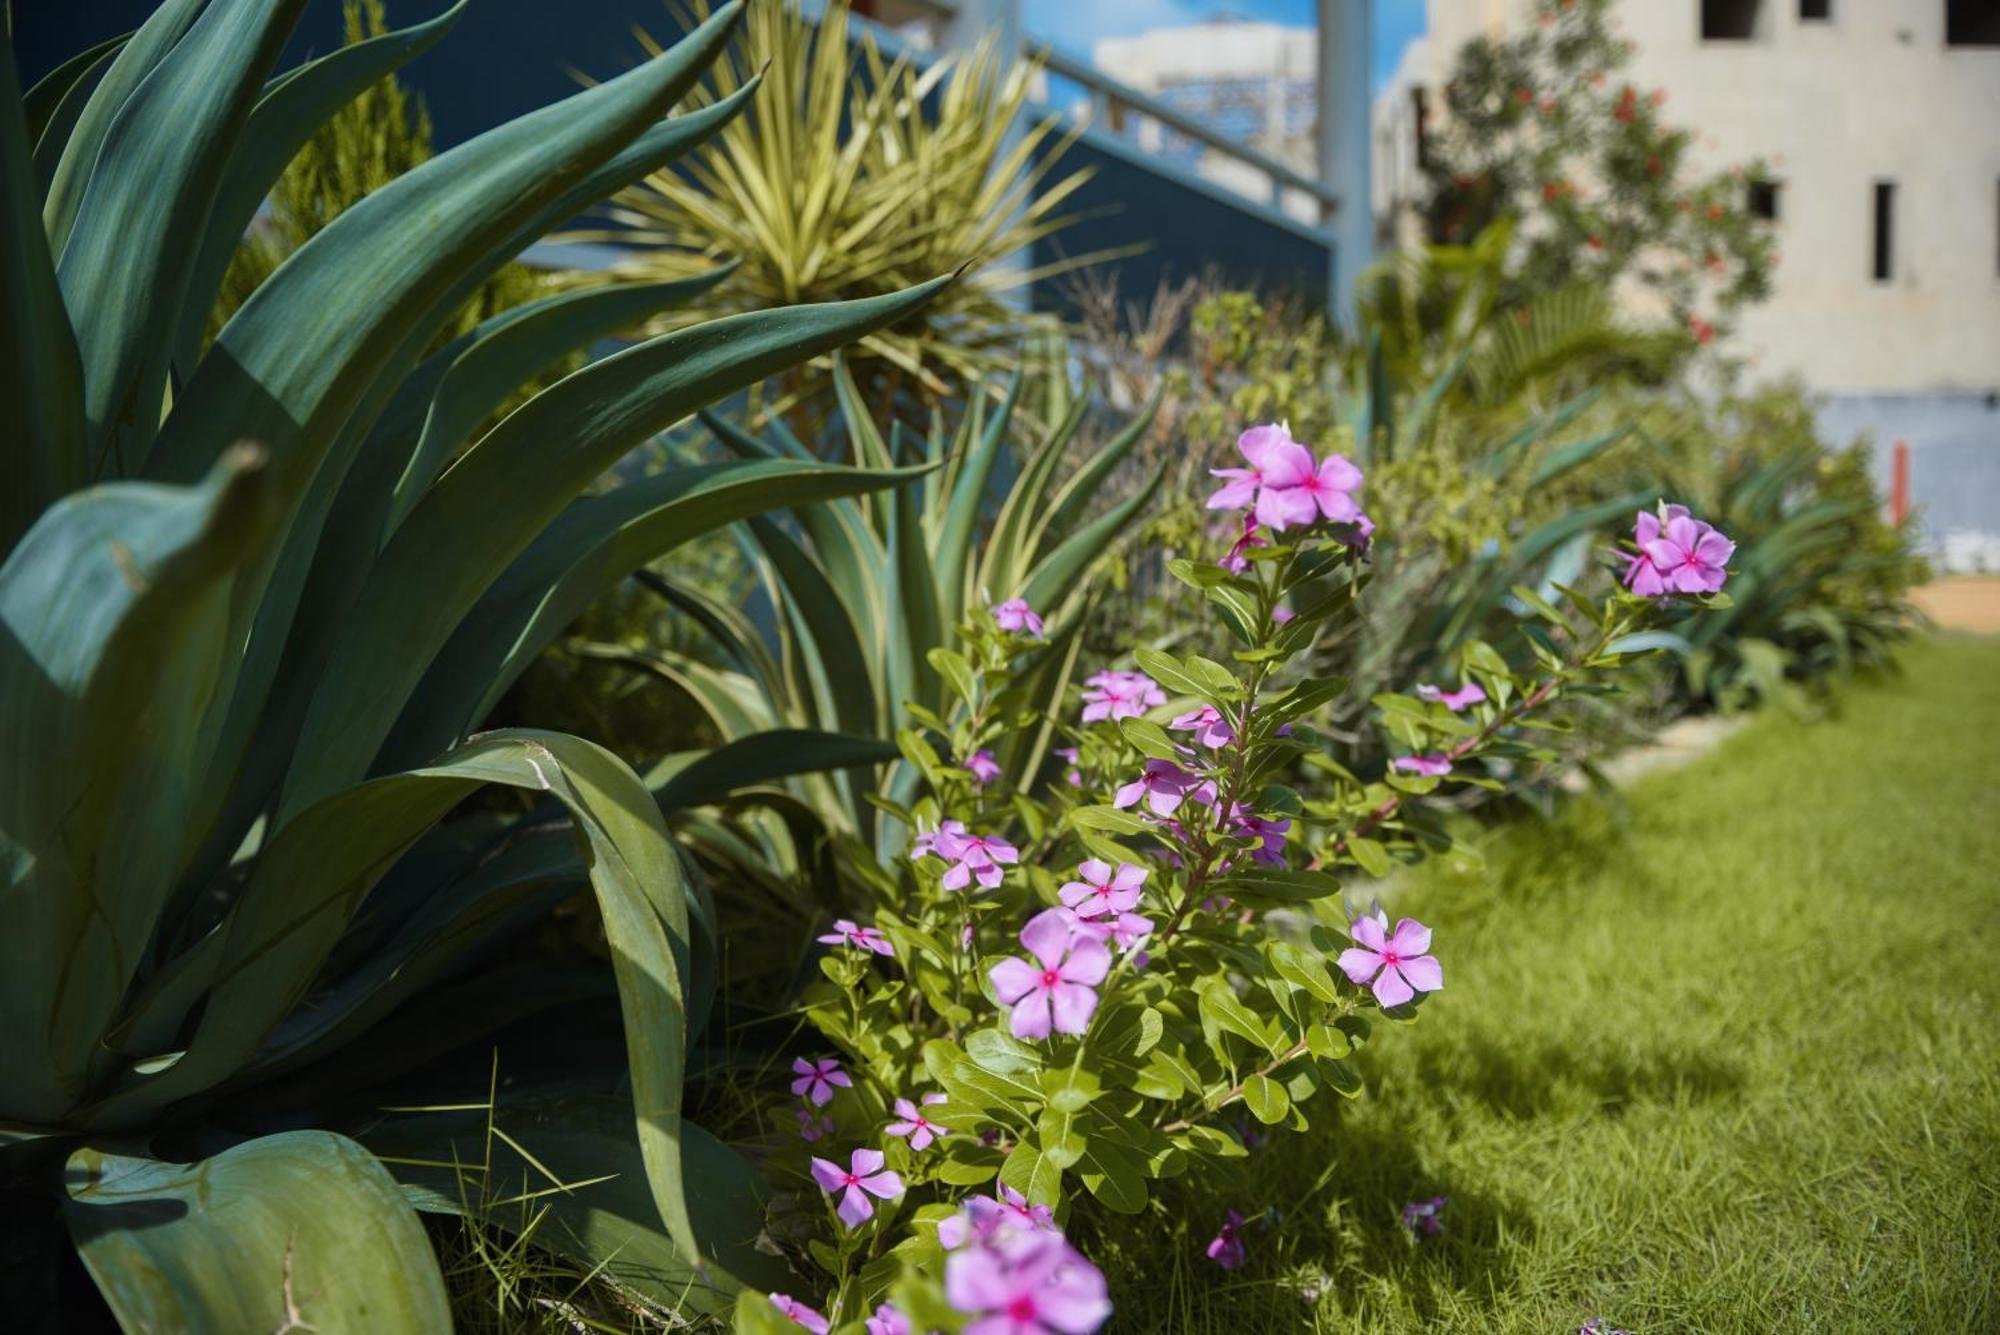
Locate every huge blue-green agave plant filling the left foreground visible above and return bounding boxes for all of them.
[0,0,938,1333]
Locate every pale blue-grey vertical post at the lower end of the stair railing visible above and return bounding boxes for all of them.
[1318,0,1374,330]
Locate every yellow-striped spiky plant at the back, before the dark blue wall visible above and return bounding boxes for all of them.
[578,0,1128,425]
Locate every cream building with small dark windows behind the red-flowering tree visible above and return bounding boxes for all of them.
[1374,0,2000,570]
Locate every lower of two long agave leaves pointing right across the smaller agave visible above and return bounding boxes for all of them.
[382,460,916,765]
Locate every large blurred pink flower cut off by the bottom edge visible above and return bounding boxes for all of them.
[944,1233,1112,1335]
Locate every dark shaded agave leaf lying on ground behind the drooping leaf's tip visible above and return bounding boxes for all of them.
[362,1095,786,1311]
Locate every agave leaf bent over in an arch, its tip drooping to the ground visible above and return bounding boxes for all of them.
[86,731,716,1255]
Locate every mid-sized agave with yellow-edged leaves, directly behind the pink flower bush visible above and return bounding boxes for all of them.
[576,358,1166,895]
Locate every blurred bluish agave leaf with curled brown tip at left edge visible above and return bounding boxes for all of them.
[0,446,274,1119]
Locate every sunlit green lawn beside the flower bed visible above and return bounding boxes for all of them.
[1084,640,2000,1335]
